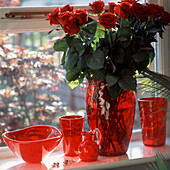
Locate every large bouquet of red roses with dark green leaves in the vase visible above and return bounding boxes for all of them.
[47,0,170,99]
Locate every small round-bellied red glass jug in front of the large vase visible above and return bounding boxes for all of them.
[79,131,99,162]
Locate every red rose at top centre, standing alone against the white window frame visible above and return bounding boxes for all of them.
[89,0,104,14]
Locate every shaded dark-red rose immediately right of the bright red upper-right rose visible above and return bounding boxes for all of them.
[131,3,148,21]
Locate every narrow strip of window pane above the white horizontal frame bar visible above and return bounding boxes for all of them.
[0,0,145,7]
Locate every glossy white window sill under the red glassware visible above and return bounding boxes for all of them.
[0,138,170,170]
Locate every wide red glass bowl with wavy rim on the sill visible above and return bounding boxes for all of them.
[2,125,62,163]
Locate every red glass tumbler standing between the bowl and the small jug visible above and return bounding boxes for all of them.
[59,115,84,156]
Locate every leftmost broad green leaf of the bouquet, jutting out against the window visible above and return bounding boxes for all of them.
[54,38,68,51]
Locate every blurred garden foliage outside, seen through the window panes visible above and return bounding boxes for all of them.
[0,0,145,146]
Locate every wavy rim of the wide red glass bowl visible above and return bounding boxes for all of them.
[2,125,62,143]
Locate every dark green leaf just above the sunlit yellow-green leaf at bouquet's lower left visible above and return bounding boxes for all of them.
[66,67,80,82]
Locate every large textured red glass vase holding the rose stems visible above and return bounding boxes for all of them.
[86,80,136,156]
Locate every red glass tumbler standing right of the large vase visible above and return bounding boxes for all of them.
[138,97,168,146]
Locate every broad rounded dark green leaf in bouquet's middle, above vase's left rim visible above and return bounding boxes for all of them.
[87,49,105,69]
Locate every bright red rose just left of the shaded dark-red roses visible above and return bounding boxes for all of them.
[115,2,131,18]
